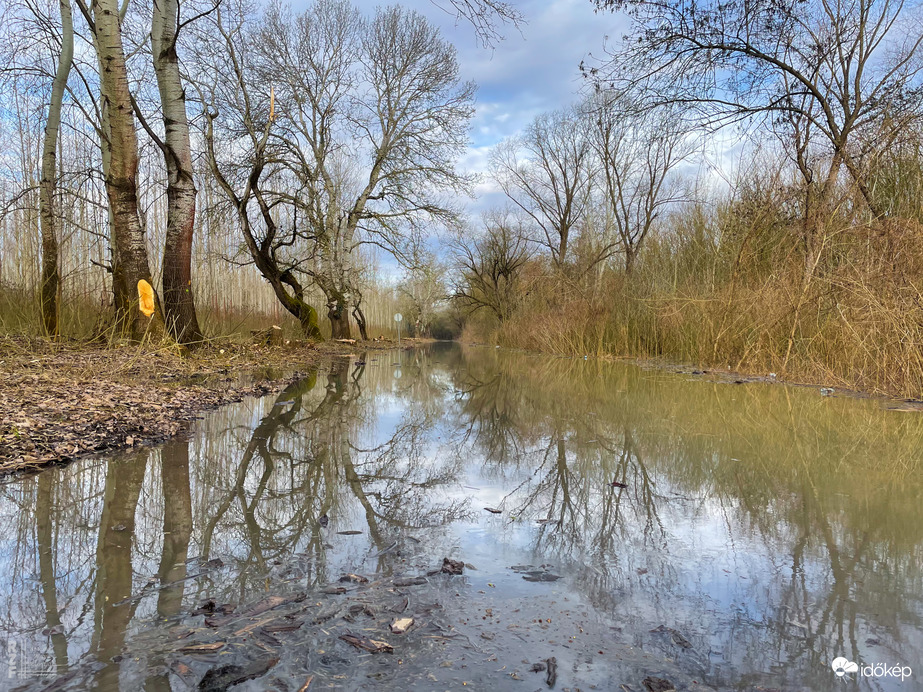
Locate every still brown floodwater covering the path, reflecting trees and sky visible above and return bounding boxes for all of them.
[0,344,923,692]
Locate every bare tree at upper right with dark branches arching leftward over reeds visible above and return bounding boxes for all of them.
[584,0,923,218]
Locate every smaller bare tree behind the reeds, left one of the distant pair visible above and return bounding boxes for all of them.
[491,108,592,268]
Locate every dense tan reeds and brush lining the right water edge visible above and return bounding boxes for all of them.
[467,173,923,398]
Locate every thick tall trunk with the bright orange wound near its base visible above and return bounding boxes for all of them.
[91,0,163,341]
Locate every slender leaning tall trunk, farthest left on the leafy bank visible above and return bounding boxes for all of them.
[39,0,74,337]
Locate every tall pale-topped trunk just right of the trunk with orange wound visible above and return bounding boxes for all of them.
[151,0,202,344]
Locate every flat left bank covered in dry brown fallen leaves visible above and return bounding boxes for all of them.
[0,337,414,474]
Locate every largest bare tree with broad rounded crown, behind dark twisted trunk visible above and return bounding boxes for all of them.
[199,0,474,338]
